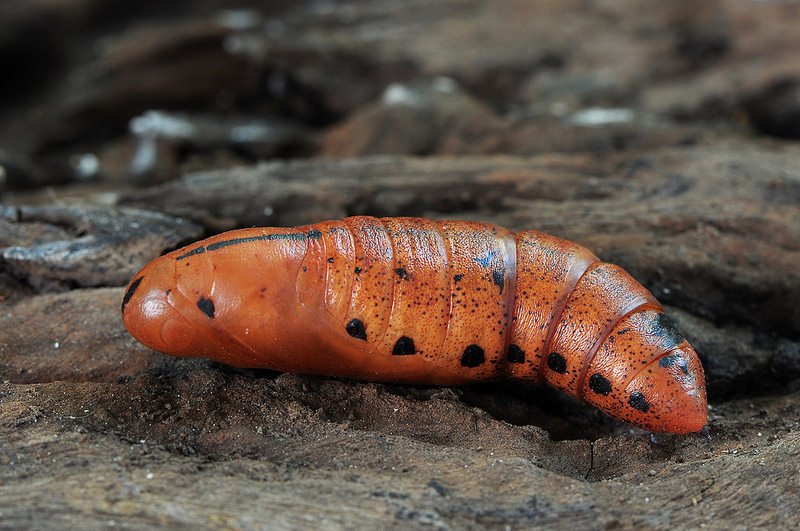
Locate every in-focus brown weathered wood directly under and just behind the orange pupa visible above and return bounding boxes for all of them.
[0,149,800,527]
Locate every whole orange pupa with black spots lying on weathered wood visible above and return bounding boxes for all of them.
[122,217,707,434]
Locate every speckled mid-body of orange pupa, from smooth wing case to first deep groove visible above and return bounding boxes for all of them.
[297,217,516,383]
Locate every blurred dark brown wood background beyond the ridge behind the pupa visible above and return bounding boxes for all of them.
[0,0,800,191]
